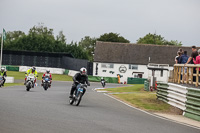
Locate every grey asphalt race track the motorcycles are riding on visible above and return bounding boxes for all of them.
[0,82,200,133]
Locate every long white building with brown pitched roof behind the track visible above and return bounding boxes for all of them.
[93,41,194,81]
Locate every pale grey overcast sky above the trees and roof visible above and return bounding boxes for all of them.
[0,0,200,46]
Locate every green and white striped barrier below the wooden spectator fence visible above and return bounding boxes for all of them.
[157,82,200,121]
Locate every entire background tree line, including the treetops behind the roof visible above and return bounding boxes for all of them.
[0,25,182,61]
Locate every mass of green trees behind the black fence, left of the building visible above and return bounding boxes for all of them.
[1,24,90,59]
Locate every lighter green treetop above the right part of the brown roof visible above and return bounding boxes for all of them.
[137,33,182,46]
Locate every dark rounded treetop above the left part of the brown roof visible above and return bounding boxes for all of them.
[97,32,130,43]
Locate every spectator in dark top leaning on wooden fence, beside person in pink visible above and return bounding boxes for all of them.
[185,46,198,82]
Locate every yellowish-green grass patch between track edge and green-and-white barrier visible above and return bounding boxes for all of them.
[105,84,171,112]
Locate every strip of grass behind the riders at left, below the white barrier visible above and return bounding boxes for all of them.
[7,71,72,81]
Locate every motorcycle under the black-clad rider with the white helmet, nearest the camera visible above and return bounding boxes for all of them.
[69,83,87,106]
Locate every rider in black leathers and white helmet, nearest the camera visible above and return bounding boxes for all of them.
[69,67,90,98]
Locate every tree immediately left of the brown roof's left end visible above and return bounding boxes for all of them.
[79,36,96,61]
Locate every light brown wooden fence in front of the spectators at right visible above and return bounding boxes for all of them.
[173,64,200,86]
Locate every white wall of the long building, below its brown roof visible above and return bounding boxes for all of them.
[93,62,173,82]
